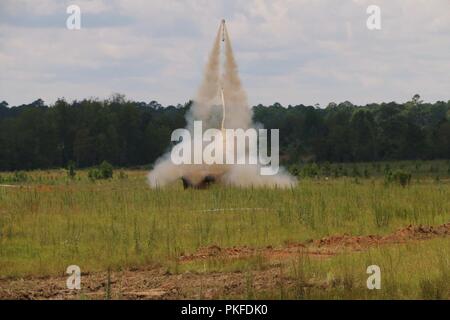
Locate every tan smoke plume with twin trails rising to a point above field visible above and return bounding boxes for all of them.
[148,21,295,187]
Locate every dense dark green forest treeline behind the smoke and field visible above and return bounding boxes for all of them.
[0,95,450,171]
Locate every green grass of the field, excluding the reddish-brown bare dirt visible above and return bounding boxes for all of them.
[0,166,450,298]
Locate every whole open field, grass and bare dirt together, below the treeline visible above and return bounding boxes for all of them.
[0,163,450,299]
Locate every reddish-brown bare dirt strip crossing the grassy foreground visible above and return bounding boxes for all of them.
[0,223,450,299]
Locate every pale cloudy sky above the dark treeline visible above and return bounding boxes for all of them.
[0,0,450,106]
